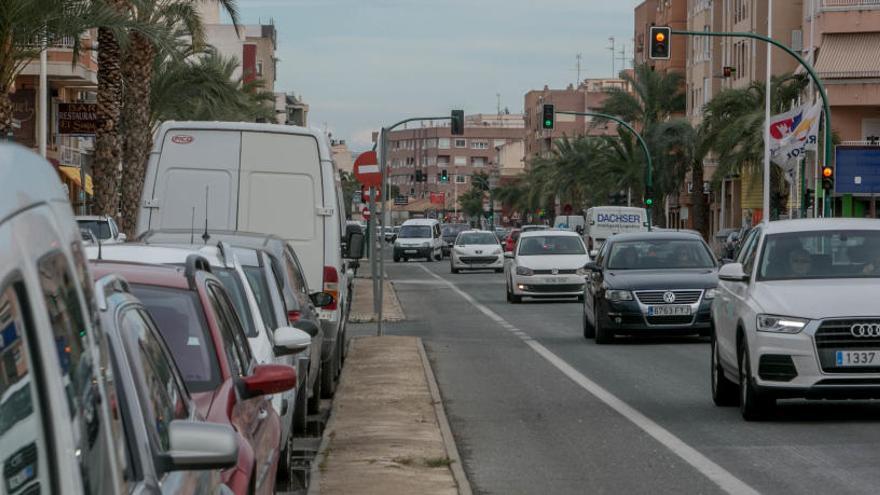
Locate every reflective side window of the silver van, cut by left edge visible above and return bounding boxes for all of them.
[0,287,54,493]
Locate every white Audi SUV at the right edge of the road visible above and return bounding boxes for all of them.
[712,219,880,420]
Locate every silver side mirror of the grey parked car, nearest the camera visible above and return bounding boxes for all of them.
[161,419,238,472]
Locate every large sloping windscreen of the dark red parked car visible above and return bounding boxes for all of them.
[131,284,220,392]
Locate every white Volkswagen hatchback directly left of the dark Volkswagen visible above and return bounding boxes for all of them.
[504,230,590,303]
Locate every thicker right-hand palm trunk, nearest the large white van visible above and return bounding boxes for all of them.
[120,33,155,236]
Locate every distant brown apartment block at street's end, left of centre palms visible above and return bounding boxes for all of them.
[388,114,523,210]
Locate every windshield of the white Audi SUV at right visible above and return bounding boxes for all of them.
[758,230,880,280]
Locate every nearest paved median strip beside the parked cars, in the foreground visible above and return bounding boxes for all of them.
[309,337,471,495]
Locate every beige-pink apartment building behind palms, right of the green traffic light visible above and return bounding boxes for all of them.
[524,79,627,161]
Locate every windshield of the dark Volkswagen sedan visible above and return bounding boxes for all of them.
[608,239,715,270]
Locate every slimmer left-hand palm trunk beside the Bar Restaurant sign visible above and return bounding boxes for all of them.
[93,20,122,218]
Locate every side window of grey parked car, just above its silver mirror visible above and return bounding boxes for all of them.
[119,307,189,451]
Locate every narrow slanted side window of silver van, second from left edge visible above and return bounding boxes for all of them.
[37,251,115,493]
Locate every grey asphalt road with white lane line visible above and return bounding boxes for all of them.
[352,261,880,494]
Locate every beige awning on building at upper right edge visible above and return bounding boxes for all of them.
[816,32,880,79]
